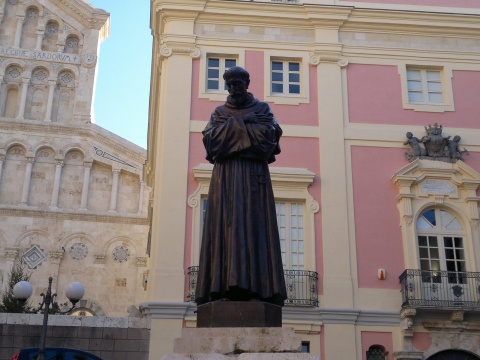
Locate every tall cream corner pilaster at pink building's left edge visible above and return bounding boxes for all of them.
[148,9,200,302]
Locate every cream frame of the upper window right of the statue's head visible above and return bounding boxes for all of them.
[264,50,310,105]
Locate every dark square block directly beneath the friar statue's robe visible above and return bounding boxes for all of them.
[197,301,282,328]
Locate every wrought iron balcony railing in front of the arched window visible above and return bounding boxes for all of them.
[400,269,480,310]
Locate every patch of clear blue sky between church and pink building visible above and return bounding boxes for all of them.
[87,0,152,148]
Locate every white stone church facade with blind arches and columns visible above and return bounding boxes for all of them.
[0,0,149,316]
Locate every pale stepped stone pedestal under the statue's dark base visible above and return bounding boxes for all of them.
[162,327,314,360]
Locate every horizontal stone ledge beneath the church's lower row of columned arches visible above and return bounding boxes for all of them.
[0,205,148,225]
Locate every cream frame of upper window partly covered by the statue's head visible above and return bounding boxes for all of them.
[198,47,245,102]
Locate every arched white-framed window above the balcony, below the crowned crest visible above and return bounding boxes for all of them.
[416,208,467,284]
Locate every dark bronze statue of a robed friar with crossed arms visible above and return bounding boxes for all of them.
[195,67,287,306]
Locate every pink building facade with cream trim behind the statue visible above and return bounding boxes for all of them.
[143,0,480,360]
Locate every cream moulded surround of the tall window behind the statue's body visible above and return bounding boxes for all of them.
[188,163,320,271]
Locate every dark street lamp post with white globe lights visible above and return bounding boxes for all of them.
[13,276,85,360]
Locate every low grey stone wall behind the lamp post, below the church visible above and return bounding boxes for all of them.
[0,314,150,360]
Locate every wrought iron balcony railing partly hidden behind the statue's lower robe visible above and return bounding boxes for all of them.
[187,266,318,306]
